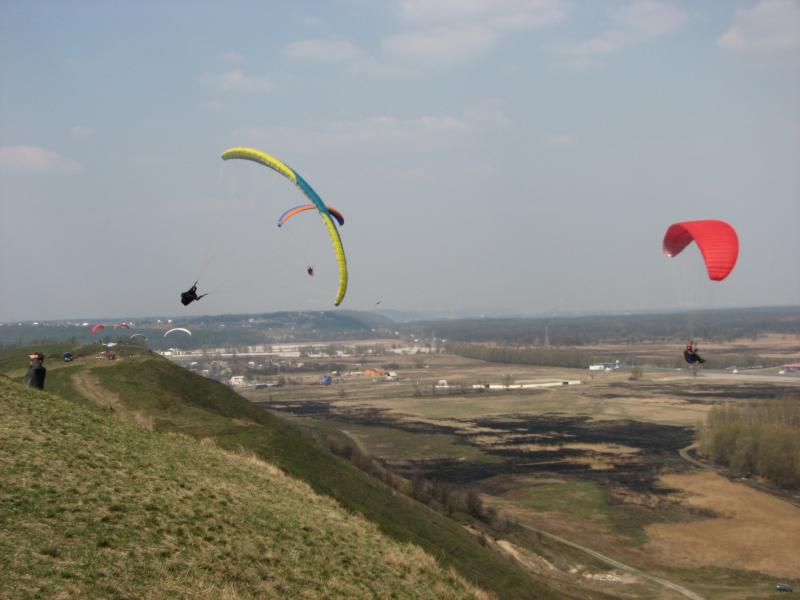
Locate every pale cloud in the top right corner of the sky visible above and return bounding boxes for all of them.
[717,0,800,52]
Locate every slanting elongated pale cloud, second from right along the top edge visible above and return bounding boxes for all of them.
[550,0,689,63]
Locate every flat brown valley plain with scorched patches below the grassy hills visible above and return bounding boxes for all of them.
[245,336,800,598]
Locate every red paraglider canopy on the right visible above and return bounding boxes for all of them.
[664,220,739,281]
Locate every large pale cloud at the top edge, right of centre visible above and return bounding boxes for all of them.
[381,0,566,65]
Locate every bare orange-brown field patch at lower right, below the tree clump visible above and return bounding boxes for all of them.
[646,472,800,577]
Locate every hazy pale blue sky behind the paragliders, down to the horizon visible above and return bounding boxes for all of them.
[0,0,800,320]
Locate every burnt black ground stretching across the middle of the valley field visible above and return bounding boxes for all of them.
[260,401,694,495]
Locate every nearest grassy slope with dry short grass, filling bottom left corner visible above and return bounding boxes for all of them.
[0,378,486,598]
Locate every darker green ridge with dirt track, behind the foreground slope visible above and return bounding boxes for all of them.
[1,346,569,598]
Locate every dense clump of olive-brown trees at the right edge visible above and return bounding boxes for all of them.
[699,397,800,489]
